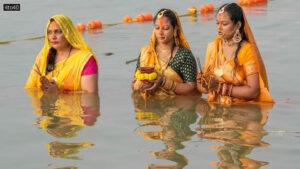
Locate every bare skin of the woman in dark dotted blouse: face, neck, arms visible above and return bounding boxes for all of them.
[132,16,196,95]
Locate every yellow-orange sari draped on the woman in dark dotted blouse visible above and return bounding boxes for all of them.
[139,10,190,95]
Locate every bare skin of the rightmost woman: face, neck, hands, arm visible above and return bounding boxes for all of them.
[197,11,259,99]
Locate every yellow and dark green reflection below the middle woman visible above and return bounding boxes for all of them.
[133,95,197,169]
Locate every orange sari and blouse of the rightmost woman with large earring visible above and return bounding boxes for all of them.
[203,5,274,104]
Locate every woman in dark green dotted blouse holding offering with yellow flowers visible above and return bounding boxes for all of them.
[132,9,197,95]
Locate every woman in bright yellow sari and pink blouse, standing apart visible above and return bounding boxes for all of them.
[25,15,98,93]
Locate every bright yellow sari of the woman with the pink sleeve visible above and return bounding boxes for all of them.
[25,15,98,91]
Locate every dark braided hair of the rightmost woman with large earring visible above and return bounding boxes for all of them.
[217,3,248,65]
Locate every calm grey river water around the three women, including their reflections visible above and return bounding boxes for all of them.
[0,0,300,169]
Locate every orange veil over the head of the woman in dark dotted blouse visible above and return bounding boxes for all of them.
[140,9,190,82]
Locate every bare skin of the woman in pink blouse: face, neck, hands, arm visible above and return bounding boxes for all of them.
[40,21,98,93]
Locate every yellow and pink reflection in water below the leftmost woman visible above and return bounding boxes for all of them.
[28,91,100,168]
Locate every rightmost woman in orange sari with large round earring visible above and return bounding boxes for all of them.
[197,3,273,104]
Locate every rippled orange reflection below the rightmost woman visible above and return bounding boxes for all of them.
[196,101,273,169]
